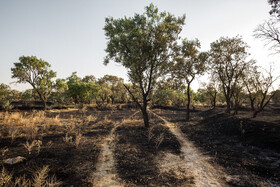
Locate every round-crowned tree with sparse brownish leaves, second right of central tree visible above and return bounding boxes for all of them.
[209,36,248,113]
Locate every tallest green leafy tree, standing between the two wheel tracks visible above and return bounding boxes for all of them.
[104,4,185,127]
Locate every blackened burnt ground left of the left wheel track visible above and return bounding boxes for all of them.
[0,107,136,186]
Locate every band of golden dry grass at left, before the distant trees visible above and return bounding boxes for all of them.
[0,111,93,143]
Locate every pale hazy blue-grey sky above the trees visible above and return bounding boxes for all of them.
[0,0,280,91]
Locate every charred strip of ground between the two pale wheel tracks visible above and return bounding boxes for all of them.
[114,112,193,186]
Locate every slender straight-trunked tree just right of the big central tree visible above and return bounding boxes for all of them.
[171,39,208,121]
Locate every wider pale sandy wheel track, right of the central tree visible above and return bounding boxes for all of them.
[151,111,226,187]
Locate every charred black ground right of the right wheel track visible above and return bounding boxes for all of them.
[155,106,280,186]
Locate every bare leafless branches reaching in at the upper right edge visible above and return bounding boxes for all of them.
[254,17,280,53]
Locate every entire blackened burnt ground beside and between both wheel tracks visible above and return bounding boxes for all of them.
[0,106,280,186]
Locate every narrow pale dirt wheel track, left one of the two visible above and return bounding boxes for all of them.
[92,111,139,187]
